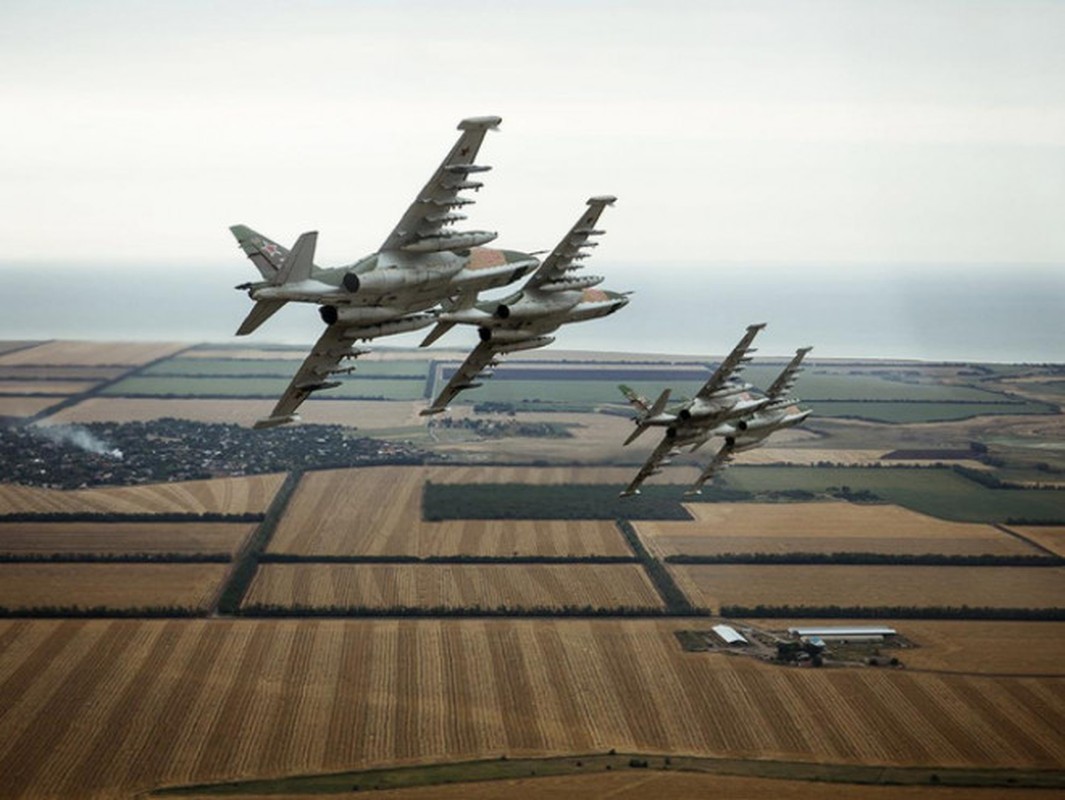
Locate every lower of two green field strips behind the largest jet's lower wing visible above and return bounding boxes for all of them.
[102,374,425,401]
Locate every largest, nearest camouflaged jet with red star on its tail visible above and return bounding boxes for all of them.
[230,117,540,428]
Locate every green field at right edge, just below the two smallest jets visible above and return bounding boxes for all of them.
[724,467,1065,522]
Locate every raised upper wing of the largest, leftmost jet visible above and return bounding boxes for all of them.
[380,117,503,252]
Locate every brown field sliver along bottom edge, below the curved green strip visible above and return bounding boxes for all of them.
[268,769,1061,800]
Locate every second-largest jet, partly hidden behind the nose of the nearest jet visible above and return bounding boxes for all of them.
[422,196,628,415]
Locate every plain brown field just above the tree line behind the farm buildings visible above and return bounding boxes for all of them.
[670,565,1065,609]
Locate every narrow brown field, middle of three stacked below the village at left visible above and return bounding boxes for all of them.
[0,522,256,555]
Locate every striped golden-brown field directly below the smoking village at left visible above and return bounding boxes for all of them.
[0,474,284,513]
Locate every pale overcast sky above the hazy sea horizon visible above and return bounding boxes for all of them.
[0,0,1065,355]
